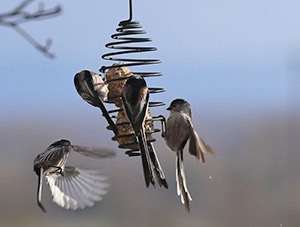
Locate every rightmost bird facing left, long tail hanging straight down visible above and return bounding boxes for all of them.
[163,99,213,211]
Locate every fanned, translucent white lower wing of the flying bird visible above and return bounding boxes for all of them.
[45,166,109,210]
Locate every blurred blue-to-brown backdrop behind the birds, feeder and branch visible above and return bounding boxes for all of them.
[0,0,300,227]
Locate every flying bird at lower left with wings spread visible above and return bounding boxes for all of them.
[33,139,115,212]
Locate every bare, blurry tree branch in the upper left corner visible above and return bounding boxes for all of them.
[0,0,62,58]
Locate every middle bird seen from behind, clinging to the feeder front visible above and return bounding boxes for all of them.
[121,75,168,188]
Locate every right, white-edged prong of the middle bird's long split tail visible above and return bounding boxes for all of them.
[149,143,168,188]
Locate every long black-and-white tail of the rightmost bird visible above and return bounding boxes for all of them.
[176,150,192,212]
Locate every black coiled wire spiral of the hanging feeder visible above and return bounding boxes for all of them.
[100,0,165,156]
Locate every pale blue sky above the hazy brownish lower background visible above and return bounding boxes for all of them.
[0,0,300,118]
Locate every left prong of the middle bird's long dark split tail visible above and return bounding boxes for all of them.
[137,129,155,187]
